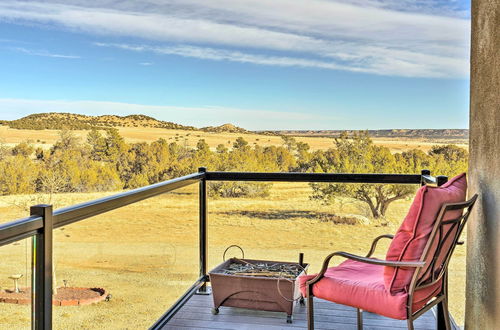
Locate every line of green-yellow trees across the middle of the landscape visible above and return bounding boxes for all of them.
[0,128,468,218]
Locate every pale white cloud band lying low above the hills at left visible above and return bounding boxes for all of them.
[0,98,336,130]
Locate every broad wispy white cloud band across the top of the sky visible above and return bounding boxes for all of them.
[0,0,470,77]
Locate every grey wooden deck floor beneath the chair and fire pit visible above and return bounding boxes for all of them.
[163,295,458,330]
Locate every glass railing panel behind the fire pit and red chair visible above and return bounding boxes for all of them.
[208,182,418,273]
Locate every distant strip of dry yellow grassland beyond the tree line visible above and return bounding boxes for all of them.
[0,126,467,152]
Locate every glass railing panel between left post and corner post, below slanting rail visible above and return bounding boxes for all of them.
[54,184,199,329]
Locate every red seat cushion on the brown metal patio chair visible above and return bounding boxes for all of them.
[298,260,441,320]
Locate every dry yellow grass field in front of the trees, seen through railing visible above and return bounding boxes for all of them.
[0,183,465,329]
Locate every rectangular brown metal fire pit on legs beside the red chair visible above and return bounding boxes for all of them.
[209,258,309,323]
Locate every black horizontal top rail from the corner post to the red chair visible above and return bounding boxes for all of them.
[206,172,424,184]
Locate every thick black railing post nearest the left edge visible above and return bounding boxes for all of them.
[30,205,53,330]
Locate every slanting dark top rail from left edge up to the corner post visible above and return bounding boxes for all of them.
[0,173,205,246]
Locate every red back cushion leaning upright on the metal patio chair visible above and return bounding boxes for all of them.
[384,173,467,293]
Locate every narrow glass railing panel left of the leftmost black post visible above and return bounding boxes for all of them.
[0,238,32,329]
